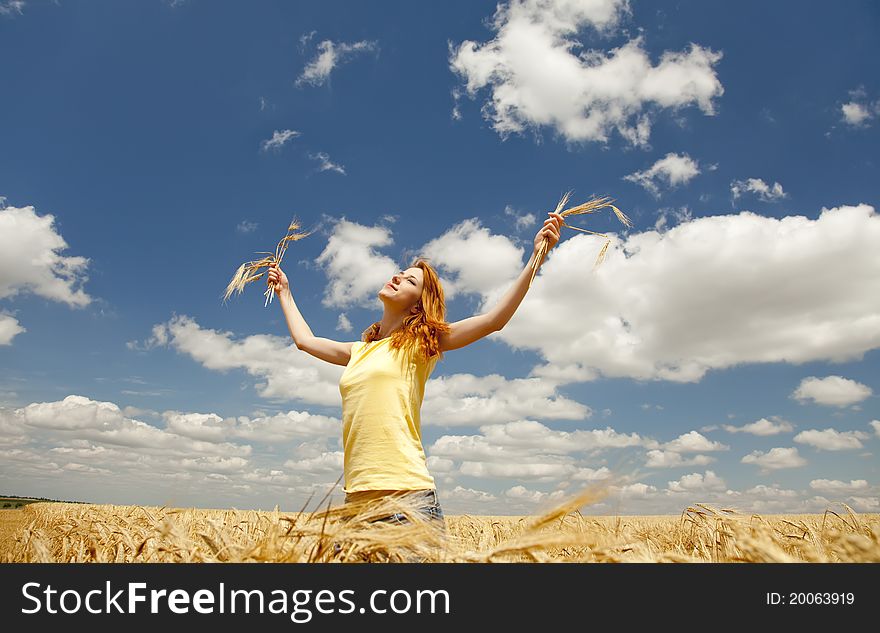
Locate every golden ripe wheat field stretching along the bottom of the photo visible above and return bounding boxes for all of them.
[0,486,880,563]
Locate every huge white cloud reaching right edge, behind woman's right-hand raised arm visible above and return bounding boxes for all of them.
[488,205,880,382]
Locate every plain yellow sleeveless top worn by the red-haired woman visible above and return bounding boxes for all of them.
[339,336,437,493]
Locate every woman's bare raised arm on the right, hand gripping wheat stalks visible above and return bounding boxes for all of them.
[440,211,563,352]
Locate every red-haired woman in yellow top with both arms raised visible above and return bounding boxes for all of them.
[267,212,563,524]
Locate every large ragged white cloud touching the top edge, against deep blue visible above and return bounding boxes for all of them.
[450,0,724,145]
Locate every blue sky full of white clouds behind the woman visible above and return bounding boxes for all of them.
[0,0,880,514]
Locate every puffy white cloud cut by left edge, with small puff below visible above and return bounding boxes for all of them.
[0,198,92,345]
